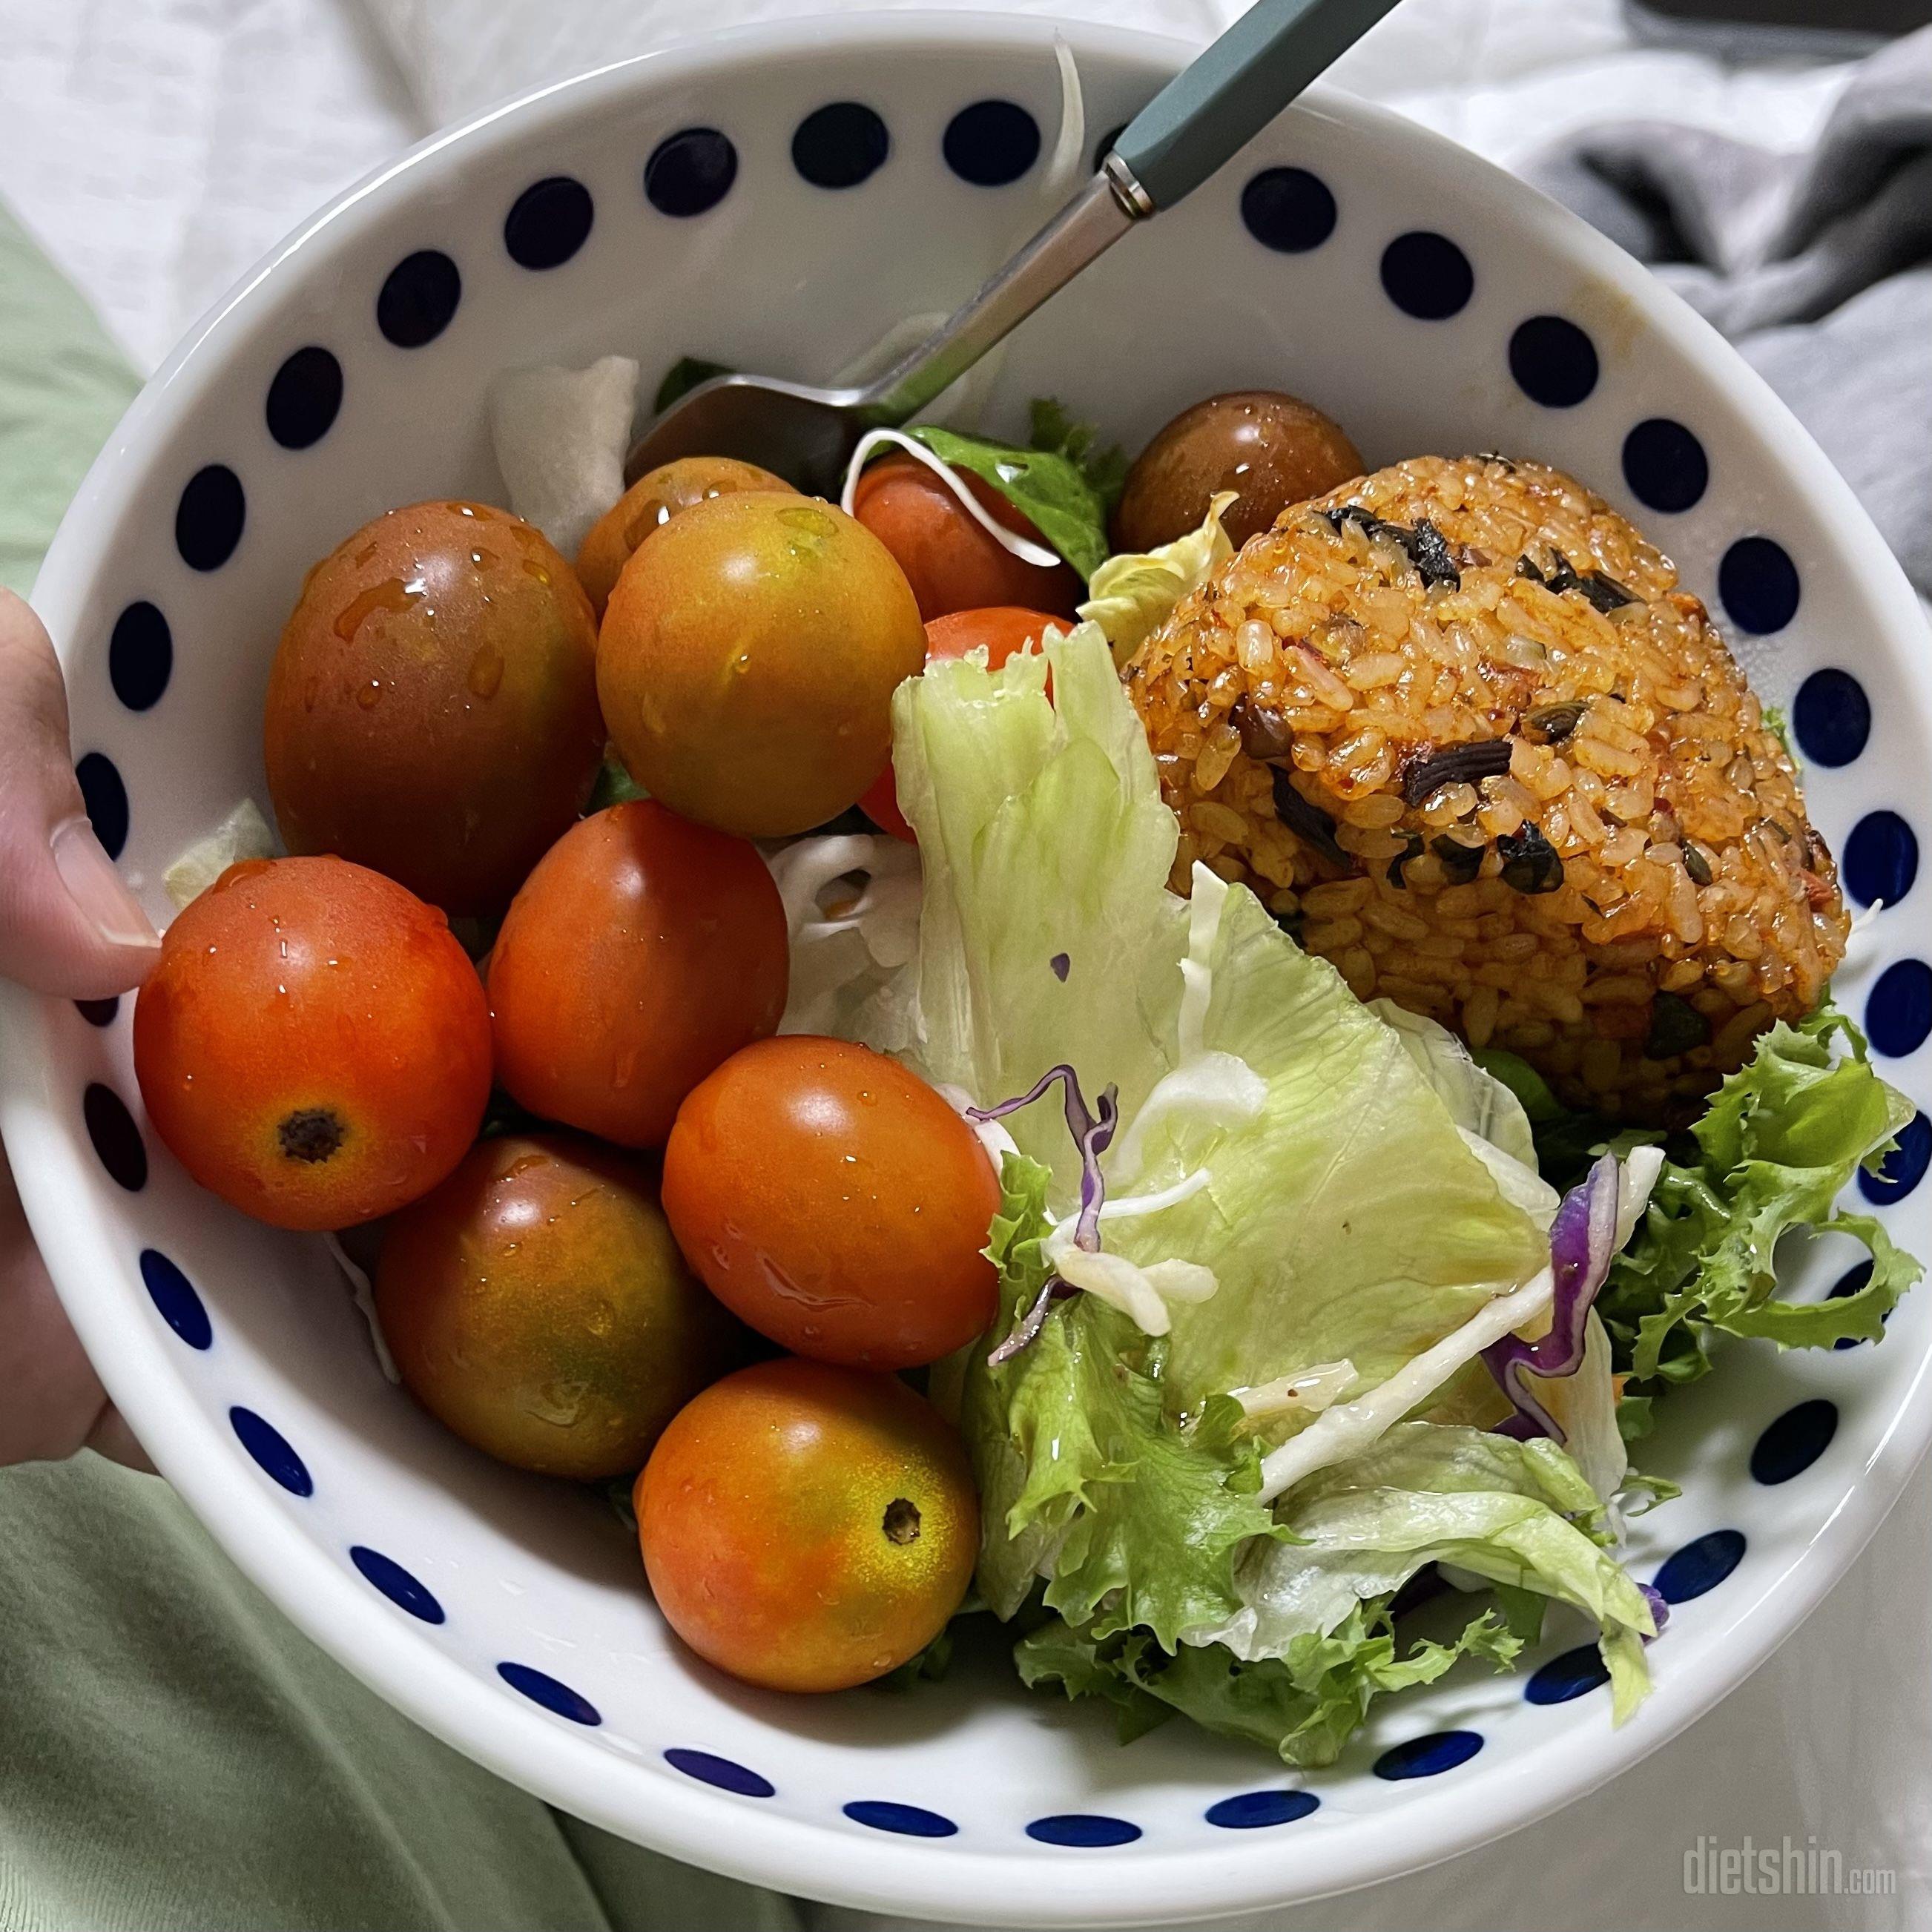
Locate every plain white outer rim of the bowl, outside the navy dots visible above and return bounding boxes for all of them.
[0,12,1932,1926]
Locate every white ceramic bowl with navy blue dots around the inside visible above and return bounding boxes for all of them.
[0,16,1932,1925]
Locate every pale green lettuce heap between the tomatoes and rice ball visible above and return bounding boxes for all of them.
[873,624,1652,1762]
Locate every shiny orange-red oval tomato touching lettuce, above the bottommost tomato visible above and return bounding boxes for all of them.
[665,1034,999,1368]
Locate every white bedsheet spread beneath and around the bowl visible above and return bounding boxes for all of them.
[0,0,1932,1932]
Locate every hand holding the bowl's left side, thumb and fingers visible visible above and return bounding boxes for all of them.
[0,590,160,1468]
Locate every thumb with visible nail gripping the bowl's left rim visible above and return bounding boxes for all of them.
[0,590,160,999]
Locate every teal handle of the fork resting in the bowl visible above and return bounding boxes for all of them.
[1112,0,1395,213]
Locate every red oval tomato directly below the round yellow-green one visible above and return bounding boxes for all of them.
[489,798,790,1147]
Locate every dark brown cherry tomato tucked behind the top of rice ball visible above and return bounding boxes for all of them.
[1112,389,1362,550]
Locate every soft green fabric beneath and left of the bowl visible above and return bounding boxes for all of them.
[0,208,799,1932]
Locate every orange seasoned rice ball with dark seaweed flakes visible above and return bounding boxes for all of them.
[1127,456,1849,1123]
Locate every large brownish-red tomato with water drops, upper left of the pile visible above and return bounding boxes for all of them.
[263,502,604,916]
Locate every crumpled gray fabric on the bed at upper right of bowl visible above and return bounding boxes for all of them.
[1524,27,1932,597]
